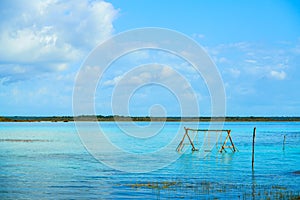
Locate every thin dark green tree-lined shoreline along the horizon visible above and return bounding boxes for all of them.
[0,115,300,122]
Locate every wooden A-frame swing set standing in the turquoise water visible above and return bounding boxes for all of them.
[176,127,237,153]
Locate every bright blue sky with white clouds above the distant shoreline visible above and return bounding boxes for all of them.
[0,0,300,116]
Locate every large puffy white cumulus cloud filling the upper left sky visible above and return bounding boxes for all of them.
[0,0,118,83]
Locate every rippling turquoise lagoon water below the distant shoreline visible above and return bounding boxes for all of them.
[0,122,300,199]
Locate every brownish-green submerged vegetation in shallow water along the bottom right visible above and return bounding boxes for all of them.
[125,180,300,199]
